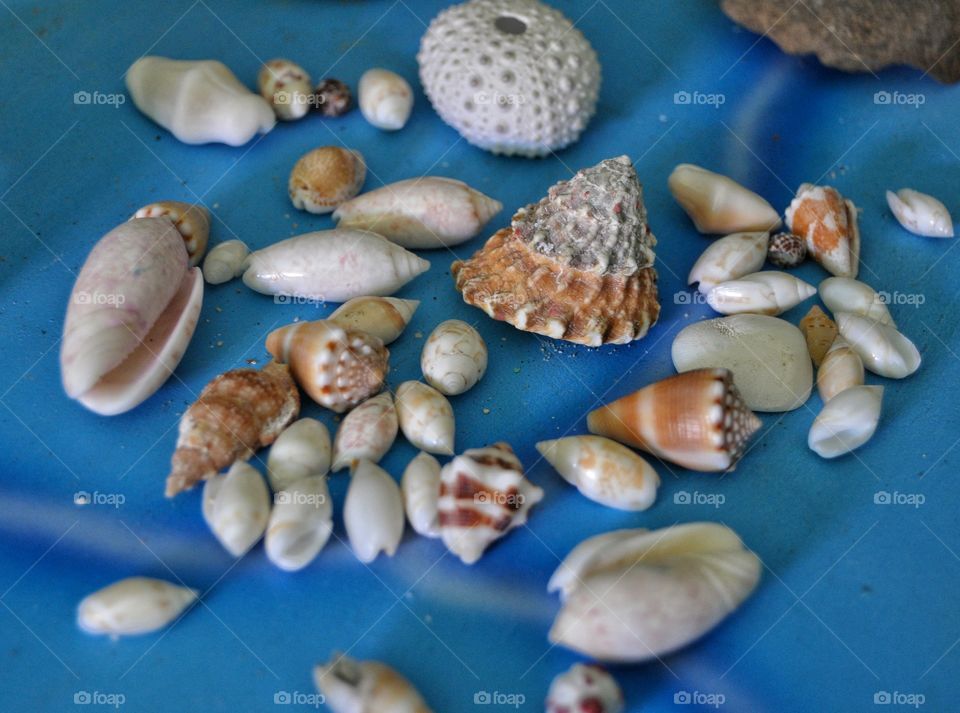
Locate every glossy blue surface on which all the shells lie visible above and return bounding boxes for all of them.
[0,0,960,713]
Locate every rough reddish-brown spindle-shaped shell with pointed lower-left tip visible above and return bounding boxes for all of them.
[166,362,300,498]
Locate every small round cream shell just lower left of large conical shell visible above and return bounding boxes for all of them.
[420,319,487,396]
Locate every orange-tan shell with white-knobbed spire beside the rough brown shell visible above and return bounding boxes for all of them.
[267,320,390,413]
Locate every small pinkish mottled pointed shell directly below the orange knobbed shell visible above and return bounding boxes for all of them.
[332,391,397,472]
